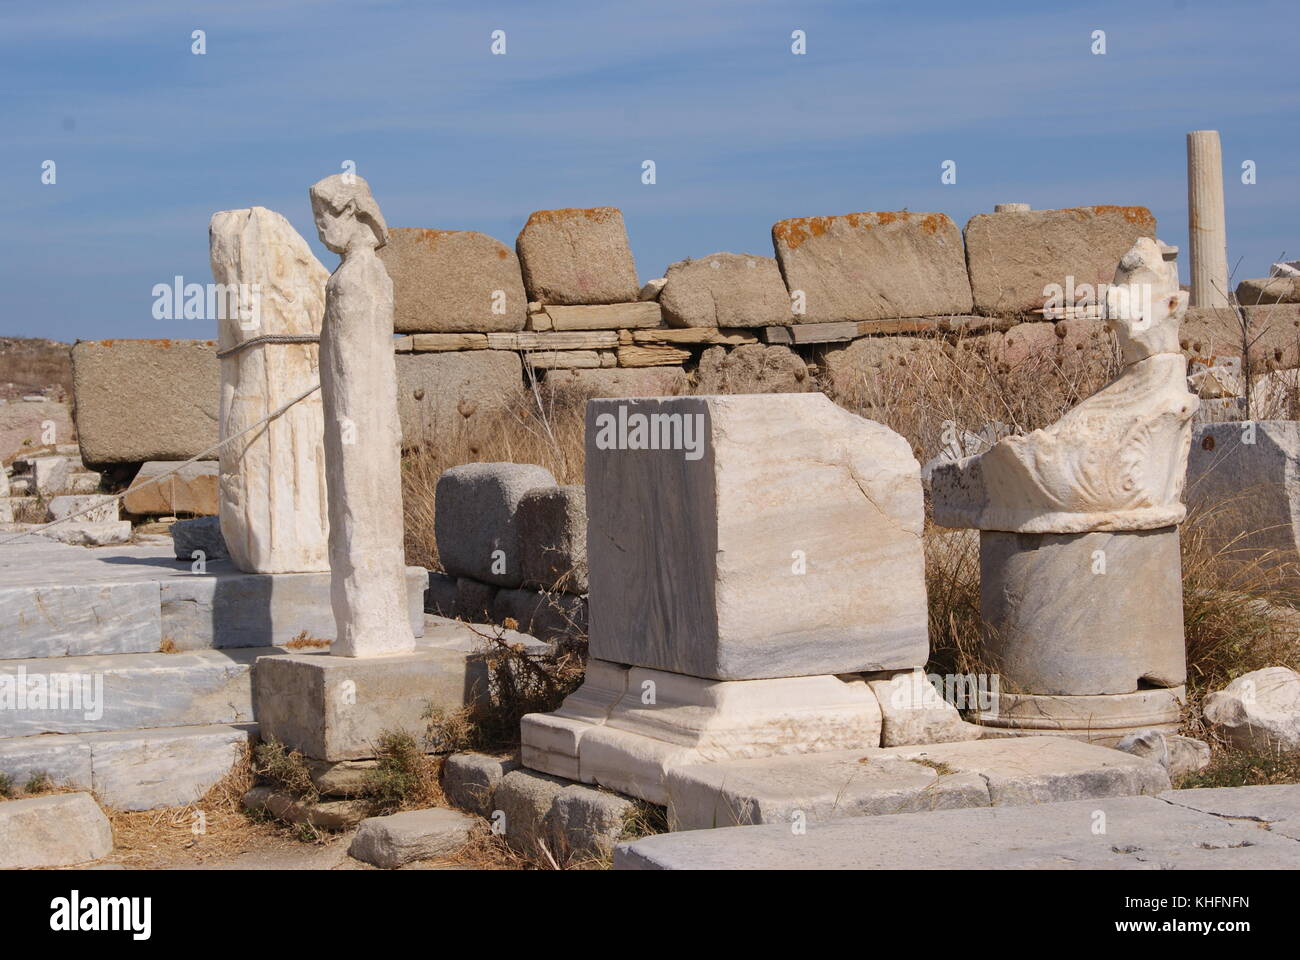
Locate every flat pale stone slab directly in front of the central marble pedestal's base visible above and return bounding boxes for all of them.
[667,751,989,830]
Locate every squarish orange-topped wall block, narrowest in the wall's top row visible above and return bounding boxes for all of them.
[515,207,641,304]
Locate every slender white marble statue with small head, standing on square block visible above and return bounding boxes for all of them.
[311,174,415,657]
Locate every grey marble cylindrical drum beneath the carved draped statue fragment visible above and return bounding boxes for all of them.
[980,527,1187,696]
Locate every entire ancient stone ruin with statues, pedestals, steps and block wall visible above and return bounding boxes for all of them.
[0,131,1300,869]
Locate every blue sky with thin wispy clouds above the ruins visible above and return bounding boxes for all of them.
[0,0,1300,340]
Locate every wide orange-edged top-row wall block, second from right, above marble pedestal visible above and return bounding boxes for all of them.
[772,211,971,324]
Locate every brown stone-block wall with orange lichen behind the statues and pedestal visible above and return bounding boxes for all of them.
[73,206,1248,464]
